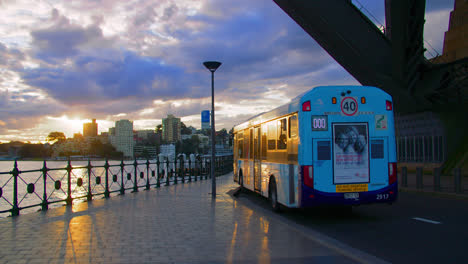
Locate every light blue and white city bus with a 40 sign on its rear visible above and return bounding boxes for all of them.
[233,86,398,211]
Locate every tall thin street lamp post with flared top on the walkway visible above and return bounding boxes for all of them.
[203,61,221,198]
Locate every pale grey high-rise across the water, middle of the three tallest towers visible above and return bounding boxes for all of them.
[109,119,134,158]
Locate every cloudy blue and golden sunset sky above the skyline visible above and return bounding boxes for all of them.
[0,0,454,142]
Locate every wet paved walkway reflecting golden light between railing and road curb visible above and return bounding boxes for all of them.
[0,174,378,263]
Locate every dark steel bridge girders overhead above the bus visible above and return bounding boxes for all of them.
[274,0,468,113]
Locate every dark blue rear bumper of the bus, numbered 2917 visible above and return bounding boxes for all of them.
[301,183,398,207]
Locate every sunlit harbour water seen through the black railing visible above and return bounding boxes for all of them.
[0,160,173,217]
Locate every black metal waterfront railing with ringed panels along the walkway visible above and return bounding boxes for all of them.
[0,154,233,216]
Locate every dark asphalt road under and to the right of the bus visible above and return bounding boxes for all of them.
[237,191,468,264]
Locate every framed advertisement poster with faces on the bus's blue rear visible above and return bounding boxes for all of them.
[333,123,369,184]
